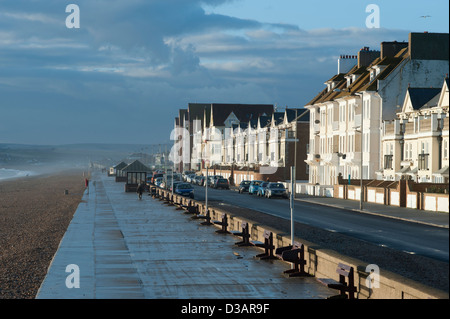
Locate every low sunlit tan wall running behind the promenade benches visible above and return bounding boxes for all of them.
[150,187,449,299]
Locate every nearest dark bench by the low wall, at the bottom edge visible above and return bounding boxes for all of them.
[318,263,357,299]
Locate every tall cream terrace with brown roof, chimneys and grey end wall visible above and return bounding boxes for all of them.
[305,33,449,195]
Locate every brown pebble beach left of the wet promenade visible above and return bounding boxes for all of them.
[0,172,85,299]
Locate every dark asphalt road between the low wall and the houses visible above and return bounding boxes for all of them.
[194,186,449,262]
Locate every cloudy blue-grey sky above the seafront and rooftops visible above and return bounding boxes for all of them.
[0,0,449,145]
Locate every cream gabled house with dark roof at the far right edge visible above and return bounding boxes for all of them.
[379,78,449,183]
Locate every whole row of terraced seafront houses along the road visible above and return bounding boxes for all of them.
[174,32,449,212]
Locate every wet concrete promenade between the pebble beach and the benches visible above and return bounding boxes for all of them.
[36,173,336,300]
